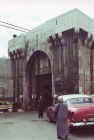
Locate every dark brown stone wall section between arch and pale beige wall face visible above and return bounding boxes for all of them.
[49,29,79,95]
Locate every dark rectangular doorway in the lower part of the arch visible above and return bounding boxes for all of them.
[36,73,52,108]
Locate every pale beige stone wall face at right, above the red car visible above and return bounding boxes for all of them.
[79,29,94,94]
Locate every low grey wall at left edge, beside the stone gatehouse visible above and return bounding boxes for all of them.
[0,58,13,101]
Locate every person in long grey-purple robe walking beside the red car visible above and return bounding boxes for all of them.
[55,97,69,140]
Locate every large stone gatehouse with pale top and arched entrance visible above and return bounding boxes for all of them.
[8,9,94,109]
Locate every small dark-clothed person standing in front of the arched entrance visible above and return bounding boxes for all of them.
[38,96,44,118]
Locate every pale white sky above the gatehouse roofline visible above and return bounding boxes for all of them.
[0,0,94,57]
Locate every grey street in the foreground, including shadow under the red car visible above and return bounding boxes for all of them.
[0,112,94,140]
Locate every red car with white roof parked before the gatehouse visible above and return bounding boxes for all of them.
[47,94,94,127]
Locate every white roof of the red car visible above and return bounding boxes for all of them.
[58,94,91,101]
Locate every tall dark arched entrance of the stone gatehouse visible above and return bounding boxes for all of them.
[27,51,52,110]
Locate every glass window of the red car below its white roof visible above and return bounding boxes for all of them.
[68,97,93,104]
